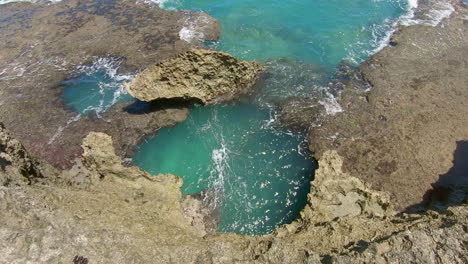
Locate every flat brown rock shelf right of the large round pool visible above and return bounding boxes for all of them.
[309,1,468,211]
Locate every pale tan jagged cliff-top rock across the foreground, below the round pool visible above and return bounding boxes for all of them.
[0,126,468,263]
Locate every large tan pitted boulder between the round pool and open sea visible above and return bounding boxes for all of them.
[125,49,264,104]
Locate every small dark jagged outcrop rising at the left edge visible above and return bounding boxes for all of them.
[0,123,44,186]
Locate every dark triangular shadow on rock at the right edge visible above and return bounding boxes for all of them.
[405,141,468,212]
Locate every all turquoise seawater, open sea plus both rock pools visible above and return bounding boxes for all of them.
[0,0,424,235]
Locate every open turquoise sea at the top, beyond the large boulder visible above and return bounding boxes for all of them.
[164,0,407,64]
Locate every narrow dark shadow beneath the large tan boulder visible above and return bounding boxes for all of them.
[123,98,202,115]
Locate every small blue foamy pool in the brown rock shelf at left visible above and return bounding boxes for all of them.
[61,58,133,116]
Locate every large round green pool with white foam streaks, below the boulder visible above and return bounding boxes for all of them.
[134,103,314,234]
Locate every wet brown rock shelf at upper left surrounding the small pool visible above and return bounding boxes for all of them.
[0,0,219,169]
